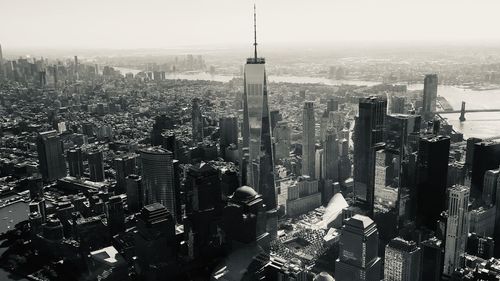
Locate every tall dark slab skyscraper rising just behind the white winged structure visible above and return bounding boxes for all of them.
[354,96,387,212]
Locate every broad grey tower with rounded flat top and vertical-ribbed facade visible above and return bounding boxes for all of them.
[140,147,176,219]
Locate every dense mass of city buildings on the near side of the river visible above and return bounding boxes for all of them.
[0,19,500,281]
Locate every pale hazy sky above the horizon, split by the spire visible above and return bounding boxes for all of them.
[0,0,500,49]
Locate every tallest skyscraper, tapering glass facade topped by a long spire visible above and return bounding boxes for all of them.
[242,8,277,210]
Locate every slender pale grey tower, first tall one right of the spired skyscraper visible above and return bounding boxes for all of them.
[302,101,316,179]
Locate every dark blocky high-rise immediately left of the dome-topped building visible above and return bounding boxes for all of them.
[185,162,222,212]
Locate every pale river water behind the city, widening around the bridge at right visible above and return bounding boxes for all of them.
[115,67,500,138]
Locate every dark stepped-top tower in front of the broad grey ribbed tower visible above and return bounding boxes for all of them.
[135,203,177,281]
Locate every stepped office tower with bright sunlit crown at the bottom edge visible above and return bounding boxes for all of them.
[335,215,381,281]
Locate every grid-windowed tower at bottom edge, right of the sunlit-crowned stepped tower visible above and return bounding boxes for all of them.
[384,237,422,281]
